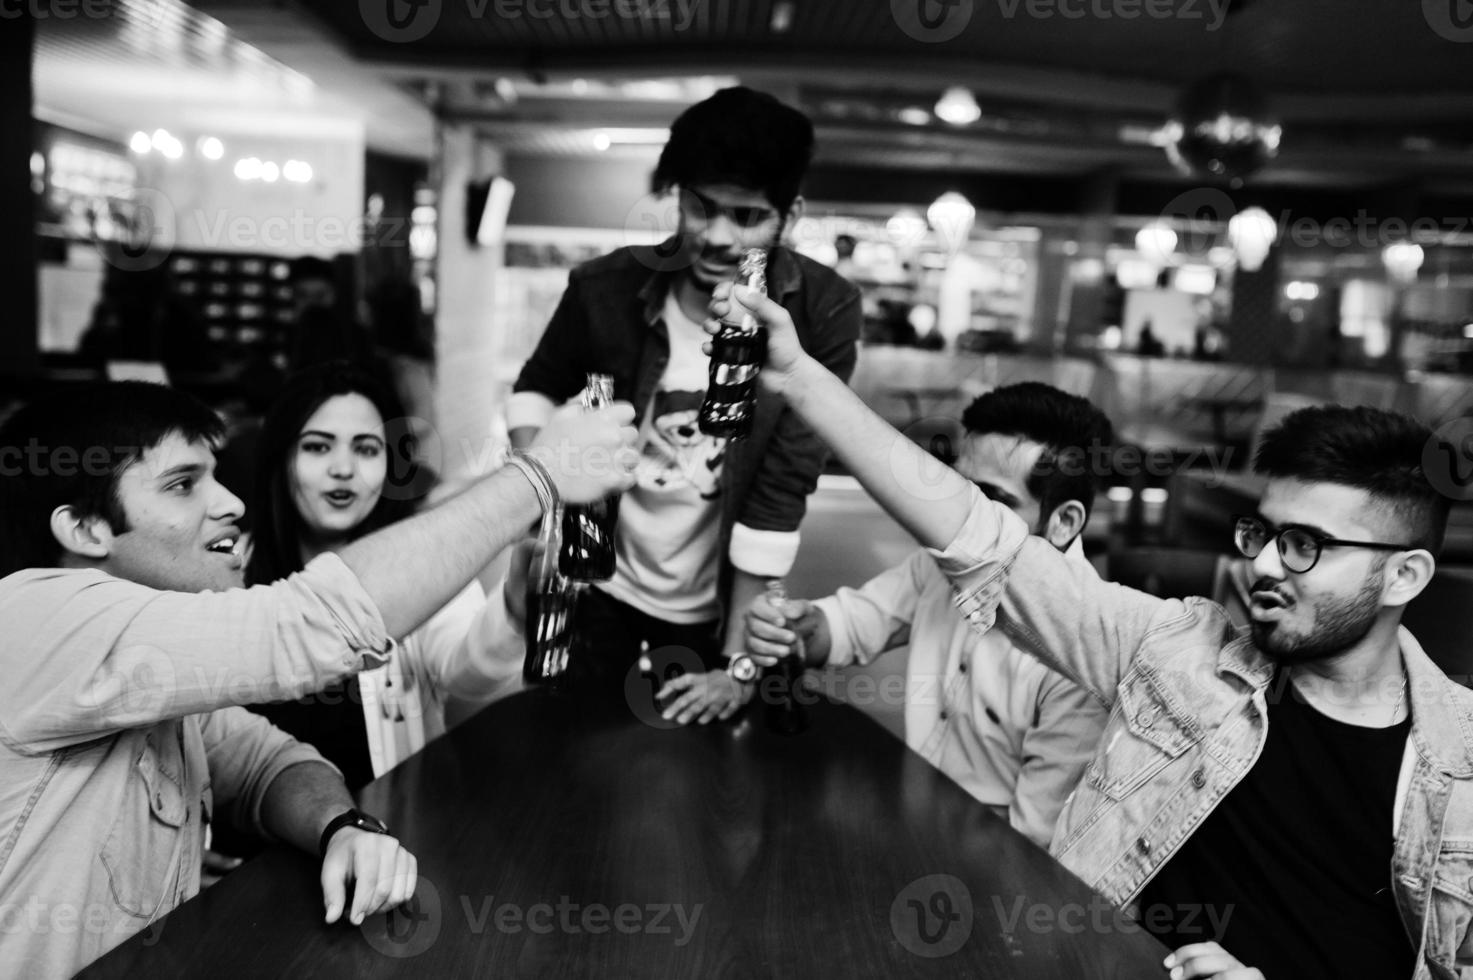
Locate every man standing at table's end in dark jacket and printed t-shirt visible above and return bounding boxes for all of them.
[507,87,862,700]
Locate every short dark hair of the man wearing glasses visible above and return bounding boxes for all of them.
[1254,405,1452,554]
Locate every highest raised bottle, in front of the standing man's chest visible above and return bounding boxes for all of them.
[697,249,767,439]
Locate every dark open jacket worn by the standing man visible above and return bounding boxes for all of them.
[516,240,862,595]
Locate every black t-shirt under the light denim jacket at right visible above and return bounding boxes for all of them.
[1140,672,1416,980]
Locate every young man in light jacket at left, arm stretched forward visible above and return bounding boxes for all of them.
[0,383,635,977]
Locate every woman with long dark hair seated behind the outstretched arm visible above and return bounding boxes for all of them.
[246,361,524,788]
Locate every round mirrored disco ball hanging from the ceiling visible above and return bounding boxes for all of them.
[1165,74,1283,187]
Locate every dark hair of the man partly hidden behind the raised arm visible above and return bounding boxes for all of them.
[962,382,1115,520]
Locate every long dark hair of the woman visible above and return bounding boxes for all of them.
[246,361,423,585]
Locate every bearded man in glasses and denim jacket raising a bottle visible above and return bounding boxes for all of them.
[730,281,1473,980]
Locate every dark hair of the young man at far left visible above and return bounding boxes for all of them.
[0,382,225,576]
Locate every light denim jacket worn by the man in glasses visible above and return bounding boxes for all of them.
[934,494,1473,980]
